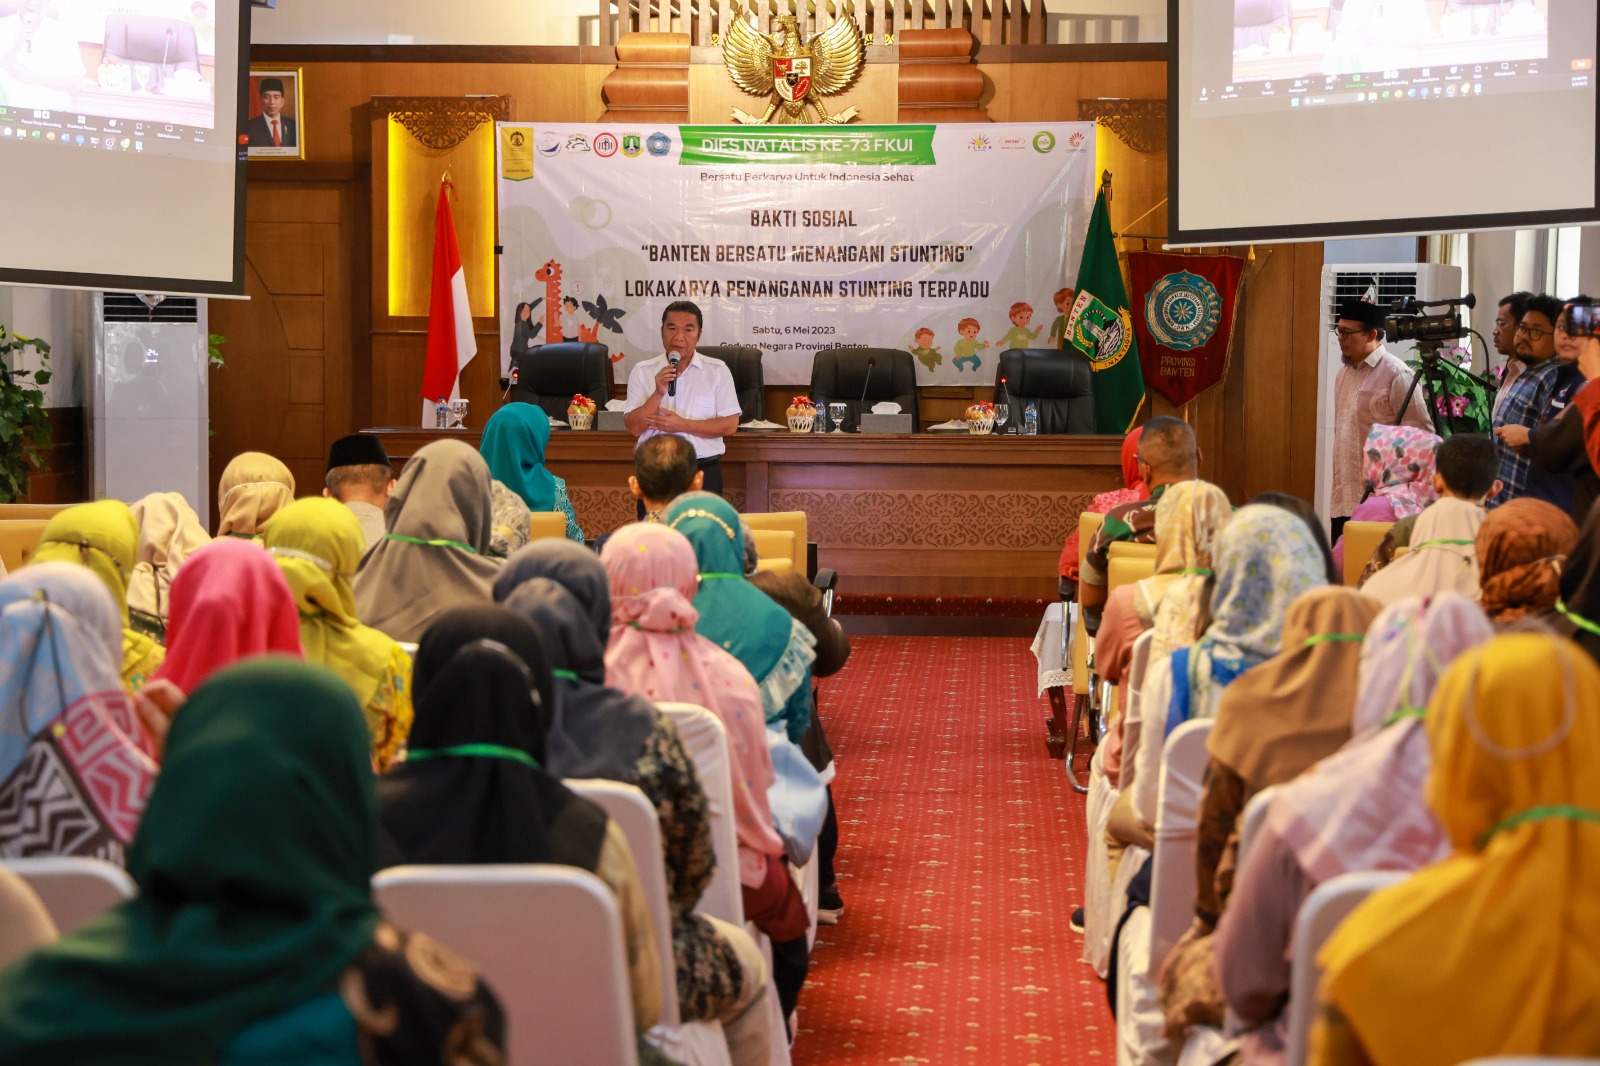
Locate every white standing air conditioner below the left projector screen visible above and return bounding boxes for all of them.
[88,293,211,520]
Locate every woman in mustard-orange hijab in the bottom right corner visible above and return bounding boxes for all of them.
[1310,634,1600,1066]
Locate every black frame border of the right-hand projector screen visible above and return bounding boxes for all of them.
[1165,0,1600,248]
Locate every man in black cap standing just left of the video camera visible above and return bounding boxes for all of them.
[1328,299,1434,541]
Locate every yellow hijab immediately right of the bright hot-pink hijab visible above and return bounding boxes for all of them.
[264,496,398,707]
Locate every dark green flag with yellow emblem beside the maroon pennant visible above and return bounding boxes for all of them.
[1067,189,1144,437]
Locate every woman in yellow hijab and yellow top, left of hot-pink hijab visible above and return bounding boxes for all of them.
[29,499,165,691]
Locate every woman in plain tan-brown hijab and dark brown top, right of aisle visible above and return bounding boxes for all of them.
[1162,586,1379,1040]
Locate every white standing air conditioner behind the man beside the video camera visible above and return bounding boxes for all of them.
[1314,262,1461,520]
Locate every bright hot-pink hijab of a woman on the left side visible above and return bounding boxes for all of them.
[155,538,302,693]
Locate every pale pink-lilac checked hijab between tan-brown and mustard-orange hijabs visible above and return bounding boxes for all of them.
[1267,592,1494,884]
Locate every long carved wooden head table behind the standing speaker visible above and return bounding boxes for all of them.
[362,426,1122,599]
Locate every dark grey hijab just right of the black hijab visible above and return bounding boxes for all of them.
[506,576,659,783]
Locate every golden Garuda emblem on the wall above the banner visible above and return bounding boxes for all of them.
[722,10,867,125]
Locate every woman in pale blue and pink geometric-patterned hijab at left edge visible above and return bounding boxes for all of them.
[0,563,155,864]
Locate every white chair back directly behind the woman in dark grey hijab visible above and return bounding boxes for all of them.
[563,779,733,1066]
